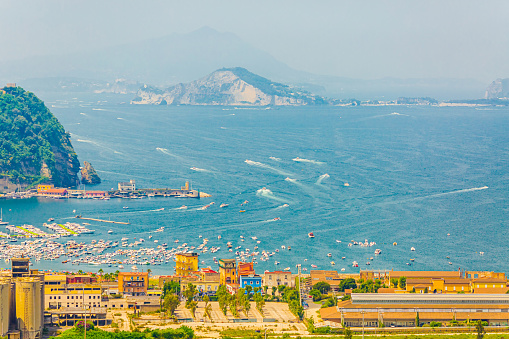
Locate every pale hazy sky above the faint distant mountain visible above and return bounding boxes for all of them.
[0,0,509,82]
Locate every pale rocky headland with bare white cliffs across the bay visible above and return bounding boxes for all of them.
[131,67,332,106]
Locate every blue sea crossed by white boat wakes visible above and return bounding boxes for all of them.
[0,93,509,274]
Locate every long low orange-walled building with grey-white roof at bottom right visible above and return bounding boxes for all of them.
[320,293,509,327]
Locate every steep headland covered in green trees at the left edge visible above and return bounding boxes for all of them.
[0,87,79,187]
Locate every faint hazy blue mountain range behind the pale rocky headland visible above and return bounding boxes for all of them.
[0,27,485,99]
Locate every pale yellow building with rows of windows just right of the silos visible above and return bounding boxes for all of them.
[44,274,106,309]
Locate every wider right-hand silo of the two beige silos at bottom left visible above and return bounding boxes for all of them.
[16,277,42,339]
